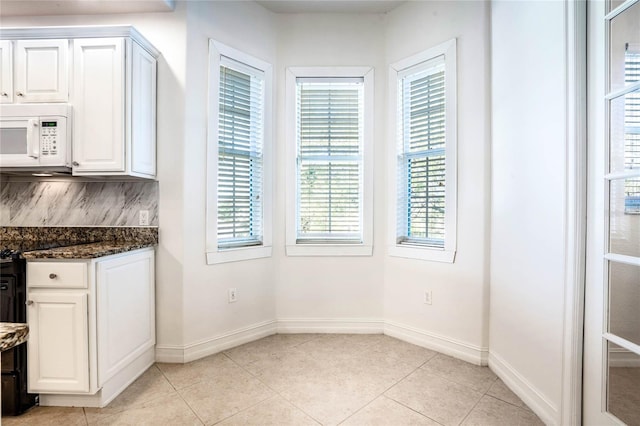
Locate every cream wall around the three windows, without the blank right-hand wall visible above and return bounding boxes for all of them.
[2,2,496,362]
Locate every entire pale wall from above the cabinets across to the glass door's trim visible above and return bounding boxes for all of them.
[2,10,580,422]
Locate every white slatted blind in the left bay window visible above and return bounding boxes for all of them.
[217,56,264,249]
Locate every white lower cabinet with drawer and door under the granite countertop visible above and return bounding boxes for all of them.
[27,248,155,407]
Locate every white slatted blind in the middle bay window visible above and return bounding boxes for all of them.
[296,78,363,243]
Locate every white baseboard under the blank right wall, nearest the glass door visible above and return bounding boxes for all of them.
[489,352,560,425]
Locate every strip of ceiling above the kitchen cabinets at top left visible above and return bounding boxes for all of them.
[0,0,175,16]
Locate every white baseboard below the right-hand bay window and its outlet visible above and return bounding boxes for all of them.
[384,321,489,365]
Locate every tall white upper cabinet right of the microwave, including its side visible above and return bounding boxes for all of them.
[72,37,156,179]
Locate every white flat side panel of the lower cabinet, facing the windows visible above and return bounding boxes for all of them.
[96,249,155,387]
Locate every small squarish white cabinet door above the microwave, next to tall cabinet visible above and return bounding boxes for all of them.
[14,40,69,103]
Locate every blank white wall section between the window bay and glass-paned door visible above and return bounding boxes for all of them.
[489,1,568,424]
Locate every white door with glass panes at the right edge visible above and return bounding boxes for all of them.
[583,0,640,425]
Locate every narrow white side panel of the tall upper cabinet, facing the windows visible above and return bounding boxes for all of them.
[127,43,156,176]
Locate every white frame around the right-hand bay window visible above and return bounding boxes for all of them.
[388,39,457,263]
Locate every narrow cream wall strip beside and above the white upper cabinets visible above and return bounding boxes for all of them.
[2,7,187,346]
